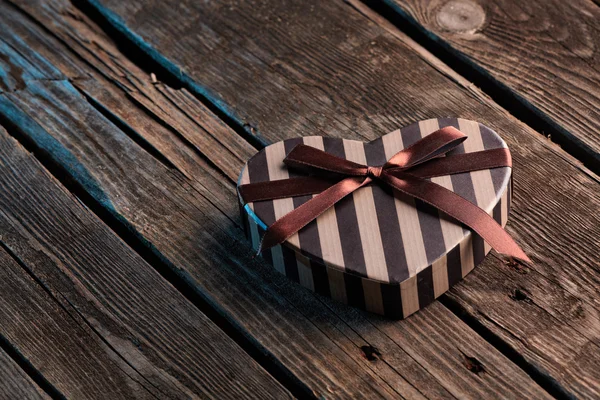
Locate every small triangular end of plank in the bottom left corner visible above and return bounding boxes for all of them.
[0,349,50,400]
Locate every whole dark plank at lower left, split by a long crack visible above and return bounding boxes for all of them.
[0,69,289,399]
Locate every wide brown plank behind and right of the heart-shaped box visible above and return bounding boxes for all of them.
[48,0,600,397]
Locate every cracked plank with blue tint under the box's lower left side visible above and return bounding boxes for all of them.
[4,3,546,398]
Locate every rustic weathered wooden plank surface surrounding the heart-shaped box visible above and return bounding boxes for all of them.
[0,0,600,399]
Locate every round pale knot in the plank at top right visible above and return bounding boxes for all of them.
[436,0,485,33]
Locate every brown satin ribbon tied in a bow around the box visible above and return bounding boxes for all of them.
[239,127,530,262]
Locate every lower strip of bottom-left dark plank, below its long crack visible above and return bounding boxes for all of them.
[0,239,154,398]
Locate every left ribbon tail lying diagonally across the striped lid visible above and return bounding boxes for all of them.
[258,177,371,254]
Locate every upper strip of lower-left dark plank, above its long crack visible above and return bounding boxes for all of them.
[2,36,286,397]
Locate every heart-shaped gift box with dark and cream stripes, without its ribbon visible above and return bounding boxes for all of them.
[238,118,511,318]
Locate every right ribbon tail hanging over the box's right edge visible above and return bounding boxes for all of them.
[381,173,531,262]
